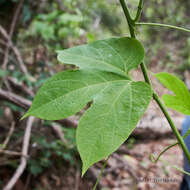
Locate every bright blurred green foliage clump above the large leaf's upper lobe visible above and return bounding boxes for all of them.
[28,9,83,49]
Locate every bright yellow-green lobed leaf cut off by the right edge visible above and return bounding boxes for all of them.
[155,72,190,115]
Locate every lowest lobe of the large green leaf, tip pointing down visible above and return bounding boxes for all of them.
[76,81,152,174]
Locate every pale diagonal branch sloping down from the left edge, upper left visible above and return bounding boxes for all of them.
[0,26,29,75]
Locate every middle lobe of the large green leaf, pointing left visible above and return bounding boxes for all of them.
[23,70,128,120]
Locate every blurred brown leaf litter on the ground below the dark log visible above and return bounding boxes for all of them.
[21,138,183,190]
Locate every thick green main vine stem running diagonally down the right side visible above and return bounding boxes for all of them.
[120,0,190,164]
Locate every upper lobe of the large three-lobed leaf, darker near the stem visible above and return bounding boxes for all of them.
[58,37,144,76]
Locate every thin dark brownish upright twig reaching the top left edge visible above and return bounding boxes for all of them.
[2,0,24,69]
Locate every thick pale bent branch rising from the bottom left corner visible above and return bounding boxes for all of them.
[3,117,34,190]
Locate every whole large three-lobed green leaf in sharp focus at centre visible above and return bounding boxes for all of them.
[24,38,152,174]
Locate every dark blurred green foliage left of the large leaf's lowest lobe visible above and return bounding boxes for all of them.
[28,127,76,176]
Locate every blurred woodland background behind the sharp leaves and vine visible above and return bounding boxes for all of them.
[0,0,190,190]
